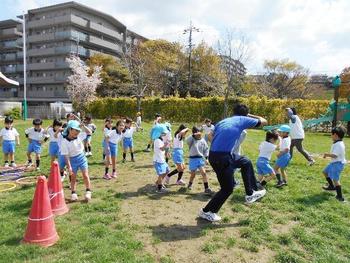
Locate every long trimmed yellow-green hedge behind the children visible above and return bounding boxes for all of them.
[86,96,329,124]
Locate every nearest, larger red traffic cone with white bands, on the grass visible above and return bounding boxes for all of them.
[22,176,59,247]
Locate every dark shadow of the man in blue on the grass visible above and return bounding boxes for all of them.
[150,221,239,242]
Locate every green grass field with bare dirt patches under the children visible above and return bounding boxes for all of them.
[0,121,350,263]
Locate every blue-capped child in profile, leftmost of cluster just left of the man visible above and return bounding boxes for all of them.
[153,126,169,194]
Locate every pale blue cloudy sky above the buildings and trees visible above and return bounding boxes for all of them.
[0,0,350,75]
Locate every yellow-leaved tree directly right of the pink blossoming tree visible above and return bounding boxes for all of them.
[87,54,132,97]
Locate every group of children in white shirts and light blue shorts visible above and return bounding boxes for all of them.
[0,113,346,204]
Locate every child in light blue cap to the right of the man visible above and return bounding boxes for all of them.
[274,125,291,187]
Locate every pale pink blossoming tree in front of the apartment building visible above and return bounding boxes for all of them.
[66,56,101,111]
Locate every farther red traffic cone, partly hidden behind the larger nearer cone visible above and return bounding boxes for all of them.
[47,161,69,216]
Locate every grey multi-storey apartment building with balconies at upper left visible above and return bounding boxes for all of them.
[0,2,145,105]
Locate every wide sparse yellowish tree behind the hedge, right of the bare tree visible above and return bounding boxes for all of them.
[255,59,312,98]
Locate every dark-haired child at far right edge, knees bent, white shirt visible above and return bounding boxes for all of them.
[323,126,346,202]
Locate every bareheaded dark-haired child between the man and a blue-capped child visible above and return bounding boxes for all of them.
[256,131,278,187]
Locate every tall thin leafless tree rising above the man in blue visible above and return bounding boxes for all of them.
[217,30,250,118]
